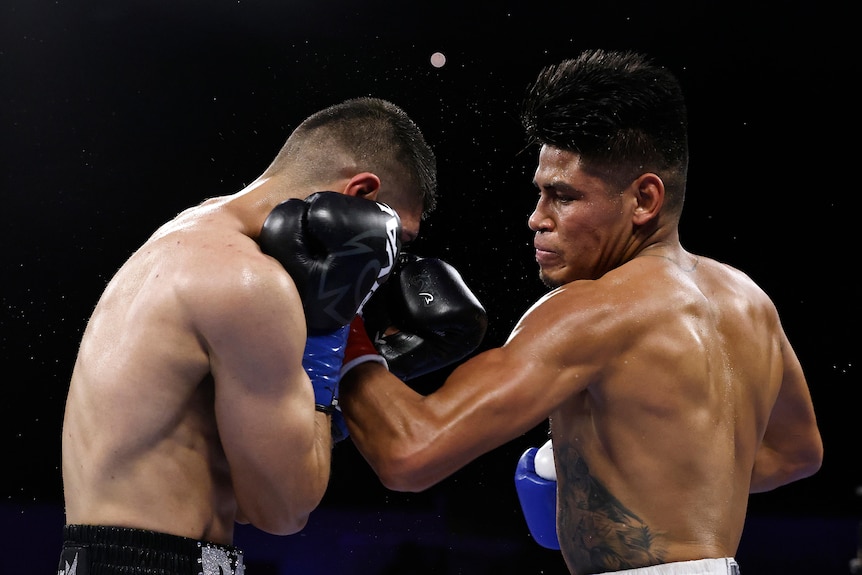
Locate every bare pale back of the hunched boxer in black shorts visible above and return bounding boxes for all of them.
[63,200,246,542]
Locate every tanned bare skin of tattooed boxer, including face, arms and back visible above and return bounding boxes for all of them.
[341,146,822,574]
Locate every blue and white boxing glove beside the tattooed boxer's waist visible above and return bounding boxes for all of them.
[515,439,560,549]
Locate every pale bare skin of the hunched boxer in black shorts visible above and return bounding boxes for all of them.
[63,173,421,545]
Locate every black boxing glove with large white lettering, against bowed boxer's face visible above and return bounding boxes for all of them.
[258,192,401,335]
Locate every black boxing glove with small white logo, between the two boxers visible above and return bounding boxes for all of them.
[362,253,488,381]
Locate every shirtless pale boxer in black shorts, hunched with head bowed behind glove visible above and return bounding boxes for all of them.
[59,98,486,575]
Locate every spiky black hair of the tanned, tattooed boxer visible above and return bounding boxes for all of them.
[521,49,688,215]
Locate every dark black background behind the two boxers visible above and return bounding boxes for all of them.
[0,0,860,575]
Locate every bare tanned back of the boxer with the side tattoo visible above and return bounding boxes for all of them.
[551,257,782,573]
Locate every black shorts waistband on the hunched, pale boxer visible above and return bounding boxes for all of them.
[57,525,245,575]
